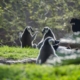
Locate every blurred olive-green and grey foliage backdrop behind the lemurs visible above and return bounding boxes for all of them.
[0,0,80,46]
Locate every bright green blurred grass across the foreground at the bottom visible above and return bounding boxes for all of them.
[0,64,80,80]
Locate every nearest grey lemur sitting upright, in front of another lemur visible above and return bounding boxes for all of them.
[36,37,58,64]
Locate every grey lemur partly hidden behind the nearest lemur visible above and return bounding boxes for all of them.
[37,27,56,49]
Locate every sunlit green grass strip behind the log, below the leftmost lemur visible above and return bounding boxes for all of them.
[0,46,39,59]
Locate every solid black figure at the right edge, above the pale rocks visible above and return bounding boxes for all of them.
[70,18,80,32]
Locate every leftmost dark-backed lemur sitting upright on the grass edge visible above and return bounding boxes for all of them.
[20,26,36,48]
